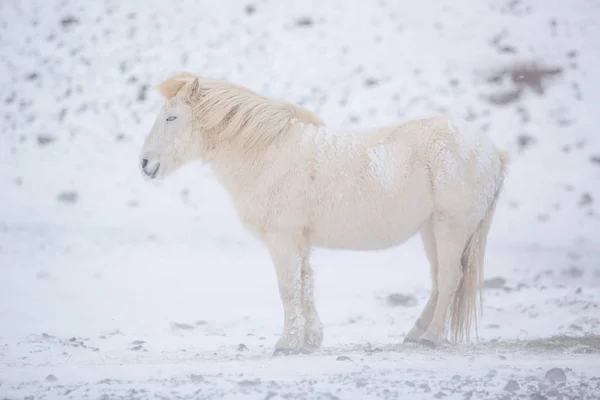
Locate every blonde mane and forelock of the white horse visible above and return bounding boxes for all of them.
[157,72,324,153]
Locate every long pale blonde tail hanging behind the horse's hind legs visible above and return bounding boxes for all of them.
[450,151,509,343]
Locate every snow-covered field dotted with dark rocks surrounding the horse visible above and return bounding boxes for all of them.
[0,0,600,399]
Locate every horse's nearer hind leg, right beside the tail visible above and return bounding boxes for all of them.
[419,215,470,346]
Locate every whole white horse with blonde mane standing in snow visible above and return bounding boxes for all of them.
[140,72,508,354]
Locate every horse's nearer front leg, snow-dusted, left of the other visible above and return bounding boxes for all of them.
[265,232,306,355]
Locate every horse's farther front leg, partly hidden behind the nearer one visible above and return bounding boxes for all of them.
[302,254,323,352]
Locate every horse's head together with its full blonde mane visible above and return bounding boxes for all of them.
[139,72,323,179]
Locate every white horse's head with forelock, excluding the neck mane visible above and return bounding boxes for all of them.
[139,73,202,179]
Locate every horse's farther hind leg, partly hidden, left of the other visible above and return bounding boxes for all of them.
[404,218,438,342]
